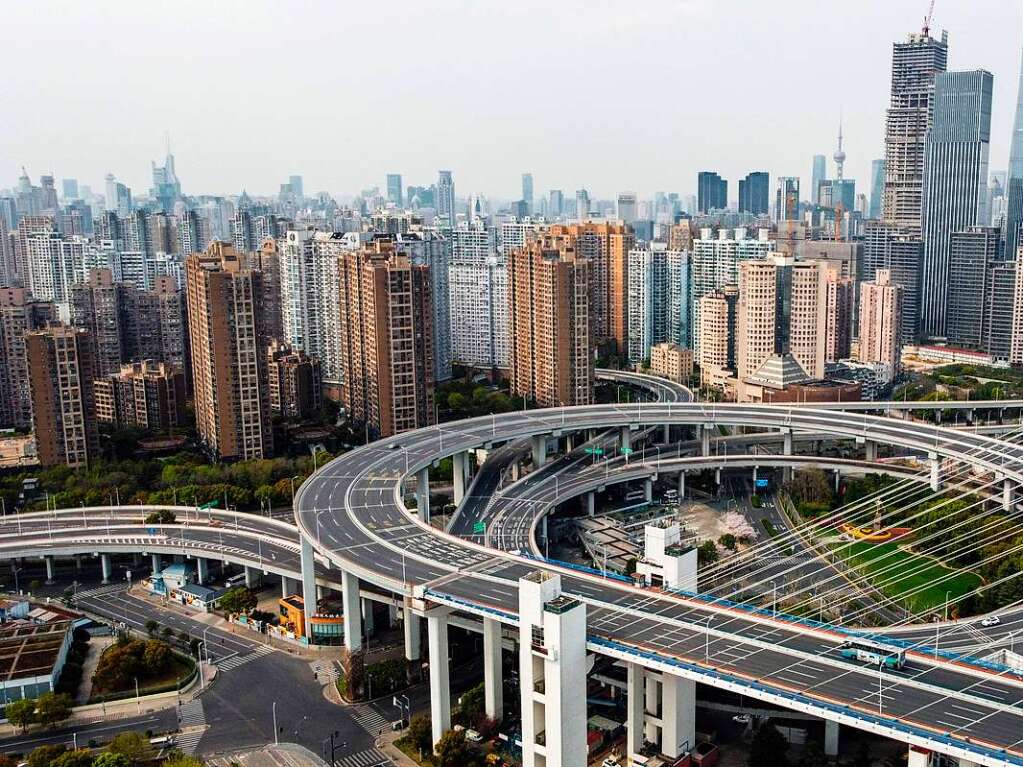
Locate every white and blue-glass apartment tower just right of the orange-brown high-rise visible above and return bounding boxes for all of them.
[627,241,692,364]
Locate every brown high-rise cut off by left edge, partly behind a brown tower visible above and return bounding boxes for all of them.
[0,287,57,428]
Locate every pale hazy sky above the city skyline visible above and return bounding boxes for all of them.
[0,0,1023,199]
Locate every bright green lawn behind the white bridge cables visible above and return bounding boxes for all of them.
[840,541,983,613]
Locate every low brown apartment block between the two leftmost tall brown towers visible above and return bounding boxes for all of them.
[93,360,185,431]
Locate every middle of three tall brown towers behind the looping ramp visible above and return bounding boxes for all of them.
[339,239,435,439]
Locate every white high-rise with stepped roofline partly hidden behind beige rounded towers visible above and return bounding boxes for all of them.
[690,227,774,353]
